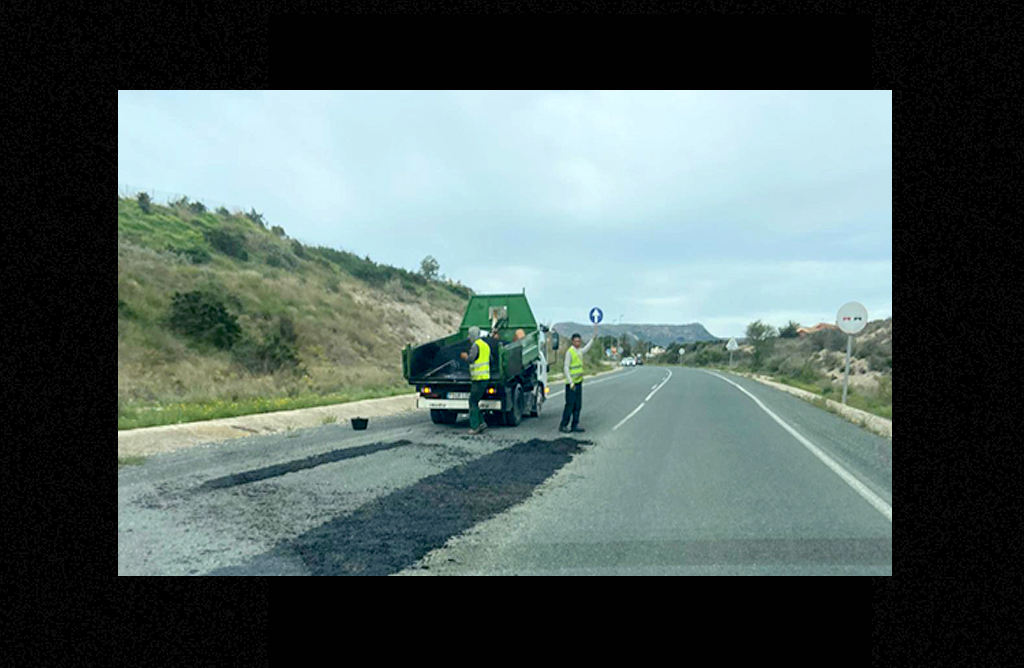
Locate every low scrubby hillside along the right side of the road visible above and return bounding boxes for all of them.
[654,318,893,419]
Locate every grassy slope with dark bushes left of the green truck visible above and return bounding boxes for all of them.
[118,198,472,428]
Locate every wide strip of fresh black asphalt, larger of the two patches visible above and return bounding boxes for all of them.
[209,439,591,575]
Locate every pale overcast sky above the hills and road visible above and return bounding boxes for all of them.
[118,91,892,337]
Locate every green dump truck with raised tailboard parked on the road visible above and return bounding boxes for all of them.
[401,294,548,426]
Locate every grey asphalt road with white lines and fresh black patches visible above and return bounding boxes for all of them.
[118,367,892,575]
